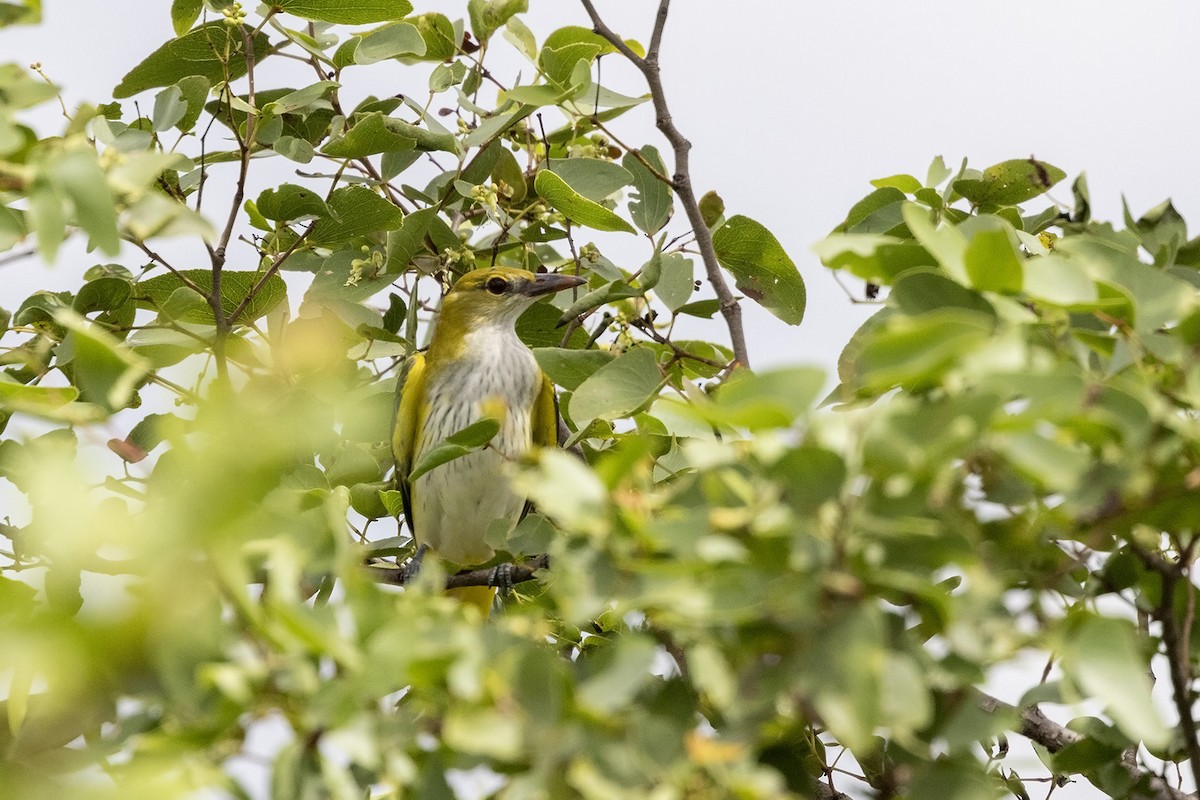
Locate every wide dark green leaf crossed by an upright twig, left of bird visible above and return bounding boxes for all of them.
[133,270,287,325]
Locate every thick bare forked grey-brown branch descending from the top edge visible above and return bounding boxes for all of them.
[580,0,750,366]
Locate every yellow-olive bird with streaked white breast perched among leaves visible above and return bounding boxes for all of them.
[391,266,586,615]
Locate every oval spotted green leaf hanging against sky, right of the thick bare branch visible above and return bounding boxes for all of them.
[713,215,805,325]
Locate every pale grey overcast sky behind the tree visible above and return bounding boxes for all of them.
[0,0,1200,798]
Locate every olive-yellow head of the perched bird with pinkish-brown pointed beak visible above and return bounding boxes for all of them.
[431,266,586,353]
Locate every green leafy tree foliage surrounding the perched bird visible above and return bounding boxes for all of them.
[0,0,1200,799]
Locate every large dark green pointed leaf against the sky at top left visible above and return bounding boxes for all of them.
[113,20,270,98]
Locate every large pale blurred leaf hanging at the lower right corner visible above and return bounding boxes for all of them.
[1061,614,1170,747]
